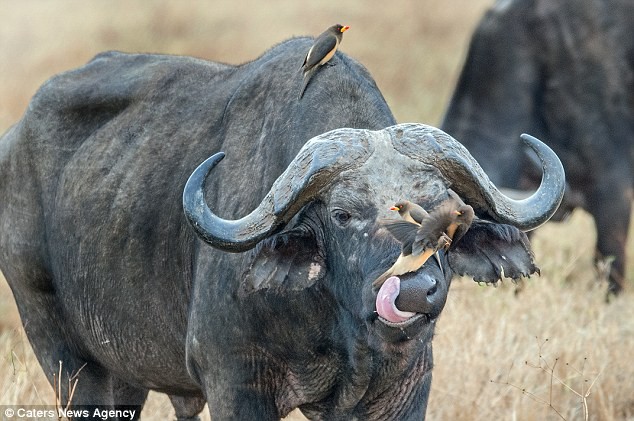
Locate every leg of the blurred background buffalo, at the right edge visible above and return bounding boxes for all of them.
[588,187,632,298]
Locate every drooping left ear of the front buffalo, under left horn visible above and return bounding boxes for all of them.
[242,229,326,293]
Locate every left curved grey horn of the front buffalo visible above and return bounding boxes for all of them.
[183,129,371,253]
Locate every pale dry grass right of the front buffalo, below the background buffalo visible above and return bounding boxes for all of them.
[429,208,634,420]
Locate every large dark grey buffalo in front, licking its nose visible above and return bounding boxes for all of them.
[0,38,564,420]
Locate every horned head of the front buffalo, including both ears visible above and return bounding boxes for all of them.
[183,120,564,342]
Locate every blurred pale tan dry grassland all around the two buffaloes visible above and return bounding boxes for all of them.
[0,0,634,420]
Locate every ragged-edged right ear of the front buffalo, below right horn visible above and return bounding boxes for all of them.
[447,220,539,282]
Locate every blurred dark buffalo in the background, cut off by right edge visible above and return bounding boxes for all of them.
[441,0,634,296]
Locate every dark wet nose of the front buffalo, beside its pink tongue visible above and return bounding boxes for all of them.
[395,274,447,317]
